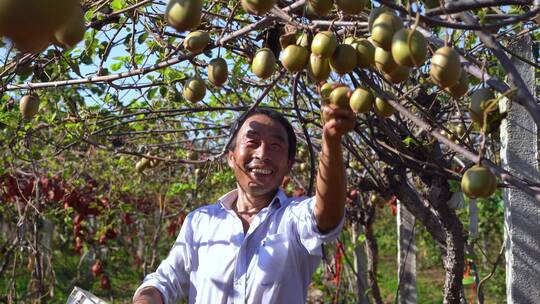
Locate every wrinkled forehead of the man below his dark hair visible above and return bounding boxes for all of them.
[238,114,288,143]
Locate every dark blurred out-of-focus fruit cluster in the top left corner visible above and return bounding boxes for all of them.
[0,0,86,53]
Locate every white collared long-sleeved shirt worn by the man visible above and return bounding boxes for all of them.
[135,189,344,304]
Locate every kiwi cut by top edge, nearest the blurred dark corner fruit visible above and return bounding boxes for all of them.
[165,0,203,32]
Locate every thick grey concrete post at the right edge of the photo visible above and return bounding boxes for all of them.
[500,36,540,303]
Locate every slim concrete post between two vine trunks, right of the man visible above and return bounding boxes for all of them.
[397,200,417,304]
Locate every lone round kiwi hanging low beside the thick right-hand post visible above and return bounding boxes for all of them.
[461,165,497,198]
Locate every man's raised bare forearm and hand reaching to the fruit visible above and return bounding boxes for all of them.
[314,105,356,233]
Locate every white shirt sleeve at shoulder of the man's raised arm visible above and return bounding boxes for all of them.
[291,196,345,256]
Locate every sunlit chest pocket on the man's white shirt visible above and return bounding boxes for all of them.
[256,234,291,285]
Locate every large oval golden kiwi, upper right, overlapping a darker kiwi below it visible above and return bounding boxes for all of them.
[429,46,461,88]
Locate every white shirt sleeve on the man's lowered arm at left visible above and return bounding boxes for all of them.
[134,214,193,304]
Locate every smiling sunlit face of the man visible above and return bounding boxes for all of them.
[228,114,294,196]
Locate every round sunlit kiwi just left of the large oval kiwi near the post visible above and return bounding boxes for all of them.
[392,29,427,68]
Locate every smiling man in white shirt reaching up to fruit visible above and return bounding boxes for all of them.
[133,106,354,304]
